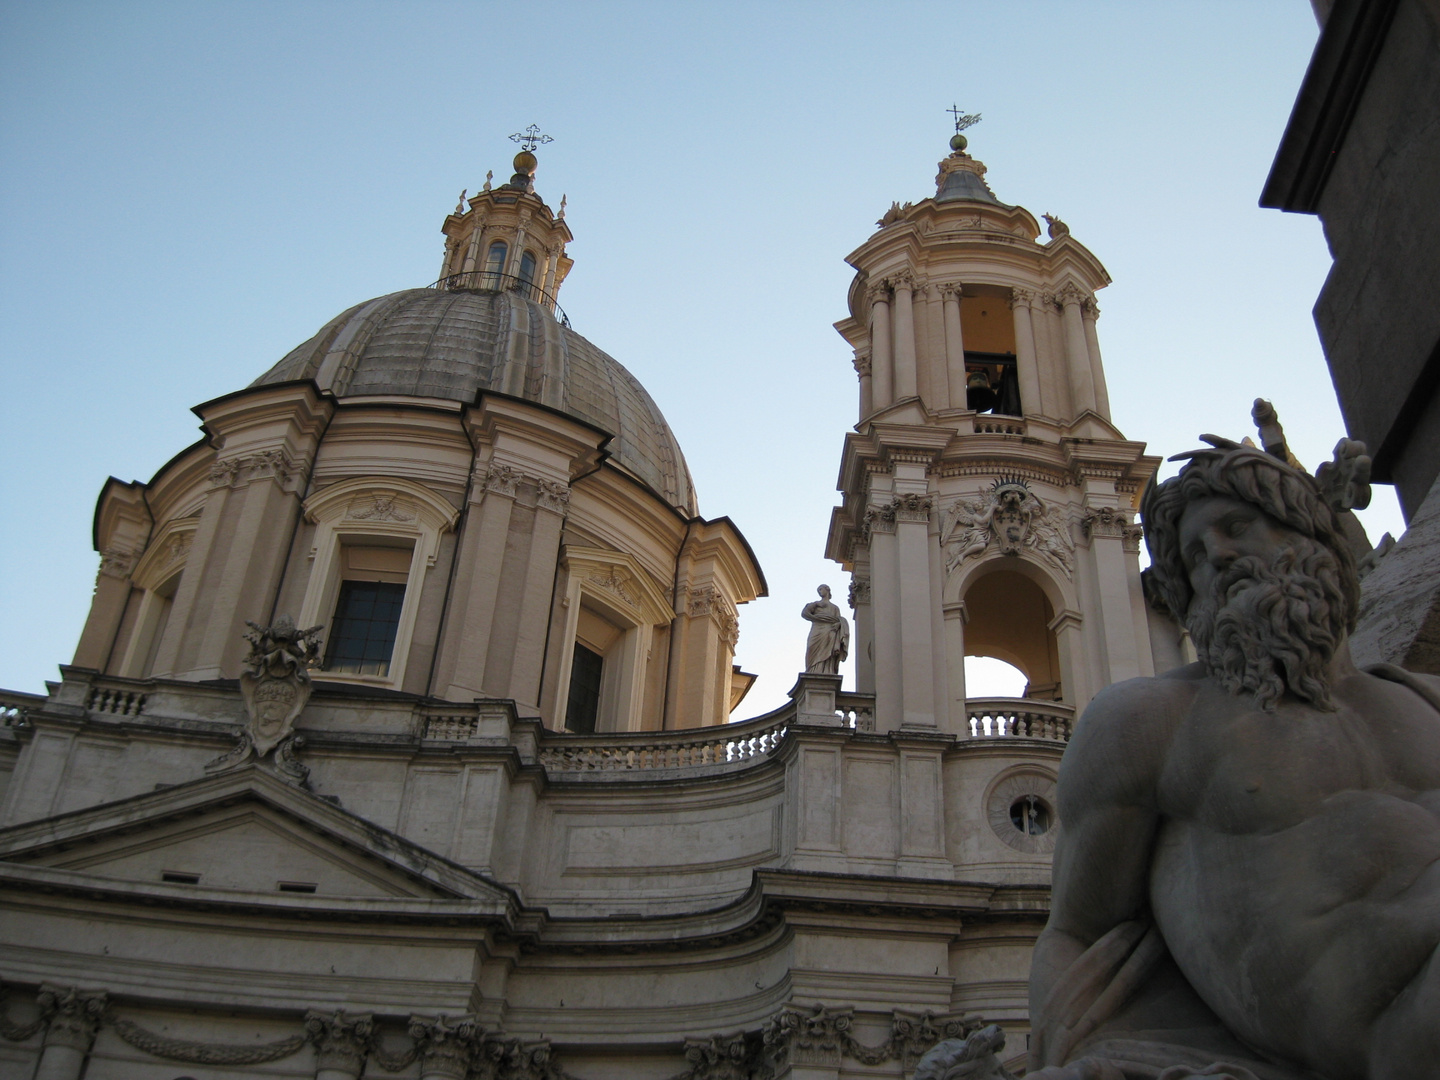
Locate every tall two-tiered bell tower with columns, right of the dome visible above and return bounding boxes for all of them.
[827,117,1182,736]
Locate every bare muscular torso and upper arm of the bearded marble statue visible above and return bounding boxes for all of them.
[1051,665,1440,1080]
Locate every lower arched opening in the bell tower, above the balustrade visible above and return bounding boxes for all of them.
[965,569,1063,701]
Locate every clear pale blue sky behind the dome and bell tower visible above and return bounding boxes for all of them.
[0,0,1400,714]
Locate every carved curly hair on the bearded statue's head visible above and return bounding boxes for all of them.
[1140,435,1359,632]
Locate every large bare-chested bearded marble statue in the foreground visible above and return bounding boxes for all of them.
[1027,436,1440,1080]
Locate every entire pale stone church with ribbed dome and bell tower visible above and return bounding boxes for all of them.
[0,139,1157,1080]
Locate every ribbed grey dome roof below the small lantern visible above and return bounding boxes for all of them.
[252,288,697,516]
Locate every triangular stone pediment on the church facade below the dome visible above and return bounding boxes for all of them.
[0,766,513,913]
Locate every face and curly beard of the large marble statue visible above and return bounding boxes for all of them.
[1178,495,1345,711]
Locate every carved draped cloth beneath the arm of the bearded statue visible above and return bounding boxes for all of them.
[1028,922,1309,1080]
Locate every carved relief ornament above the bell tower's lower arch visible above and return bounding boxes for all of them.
[940,477,1074,577]
